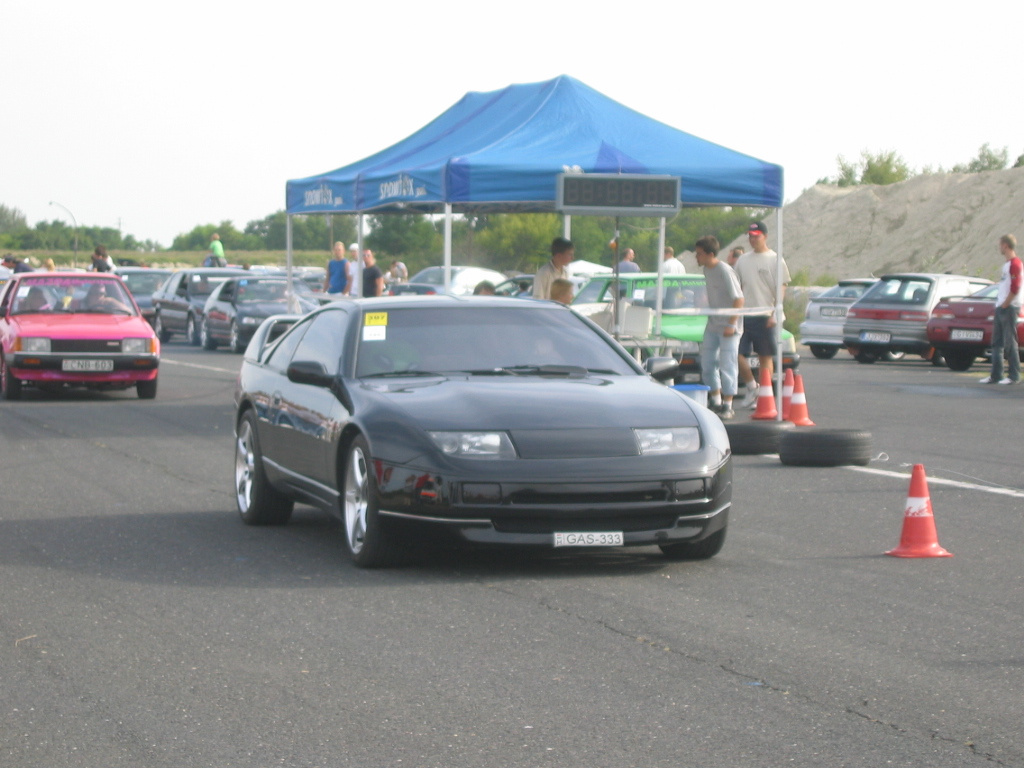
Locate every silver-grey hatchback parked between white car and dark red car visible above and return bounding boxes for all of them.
[843,272,991,365]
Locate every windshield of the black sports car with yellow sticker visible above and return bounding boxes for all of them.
[355,306,637,378]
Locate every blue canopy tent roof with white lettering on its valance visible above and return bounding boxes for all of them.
[286,75,782,215]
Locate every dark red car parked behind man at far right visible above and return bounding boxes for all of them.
[928,284,1024,371]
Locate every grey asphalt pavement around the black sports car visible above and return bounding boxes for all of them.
[0,342,1024,768]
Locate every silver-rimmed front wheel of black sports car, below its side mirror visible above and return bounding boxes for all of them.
[341,435,400,568]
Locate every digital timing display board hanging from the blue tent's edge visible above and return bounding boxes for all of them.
[555,173,679,216]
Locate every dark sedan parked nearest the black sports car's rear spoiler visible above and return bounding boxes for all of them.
[200,275,321,352]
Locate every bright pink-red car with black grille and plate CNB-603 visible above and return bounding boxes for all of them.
[0,272,160,400]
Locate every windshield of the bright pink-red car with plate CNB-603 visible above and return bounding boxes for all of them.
[11,275,136,314]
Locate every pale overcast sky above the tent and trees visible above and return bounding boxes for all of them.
[0,0,1024,246]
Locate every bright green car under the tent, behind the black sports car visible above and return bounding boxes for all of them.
[572,272,800,382]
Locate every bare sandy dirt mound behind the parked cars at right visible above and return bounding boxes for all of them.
[730,168,1024,282]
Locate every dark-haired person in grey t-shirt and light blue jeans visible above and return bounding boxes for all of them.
[694,236,743,419]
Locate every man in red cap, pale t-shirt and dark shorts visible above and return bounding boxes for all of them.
[736,221,791,408]
